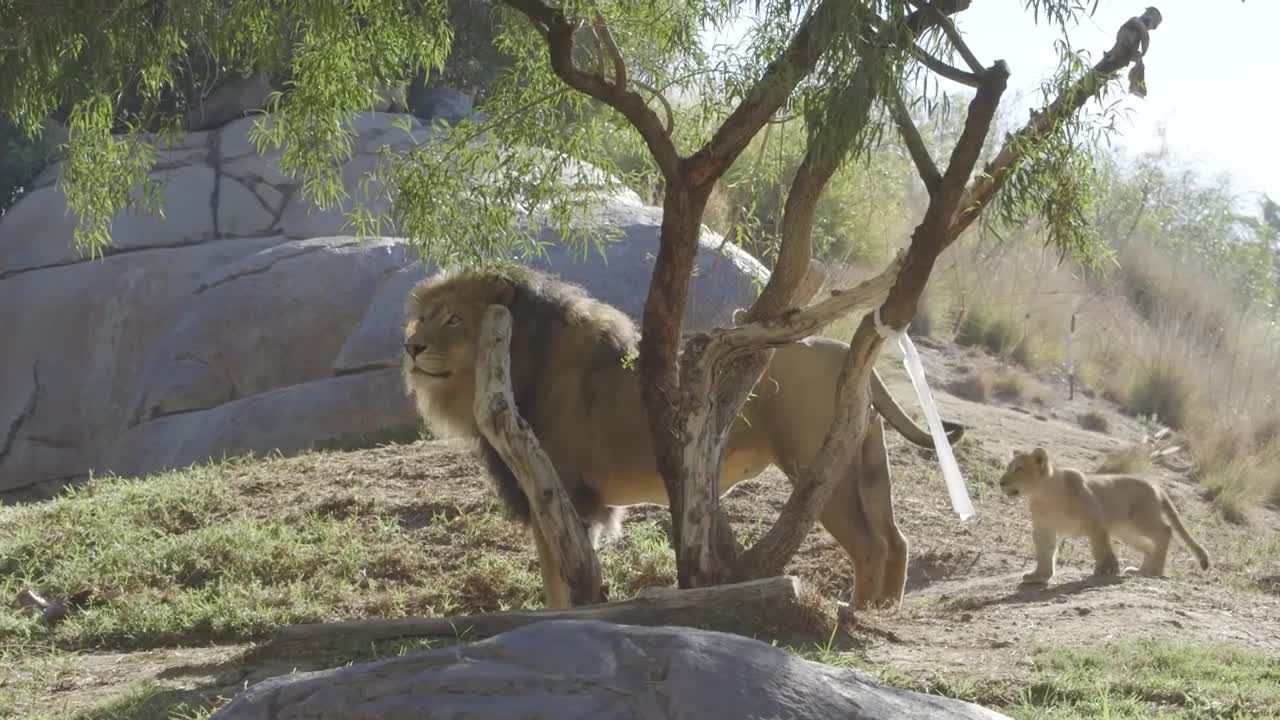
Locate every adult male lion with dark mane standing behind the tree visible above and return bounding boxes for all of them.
[403,270,964,606]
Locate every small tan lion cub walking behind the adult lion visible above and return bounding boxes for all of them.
[1000,447,1208,584]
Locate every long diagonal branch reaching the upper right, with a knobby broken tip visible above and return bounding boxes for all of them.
[947,9,1158,238]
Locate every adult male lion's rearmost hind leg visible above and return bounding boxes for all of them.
[851,410,910,607]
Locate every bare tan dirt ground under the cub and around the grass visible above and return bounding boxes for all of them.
[10,345,1280,706]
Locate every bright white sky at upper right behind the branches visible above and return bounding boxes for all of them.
[704,0,1280,210]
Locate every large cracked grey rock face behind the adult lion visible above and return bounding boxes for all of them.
[0,110,767,501]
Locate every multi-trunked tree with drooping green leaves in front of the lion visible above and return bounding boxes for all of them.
[0,0,1153,599]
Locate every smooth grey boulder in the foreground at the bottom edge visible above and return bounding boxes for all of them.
[212,620,1007,720]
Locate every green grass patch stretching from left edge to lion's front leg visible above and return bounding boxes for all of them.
[0,461,552,650]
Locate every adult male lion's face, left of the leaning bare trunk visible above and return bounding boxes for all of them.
[402,273,516,434]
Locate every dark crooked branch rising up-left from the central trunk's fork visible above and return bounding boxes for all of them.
[503,0,681,183]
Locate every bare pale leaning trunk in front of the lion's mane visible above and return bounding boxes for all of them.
[474,305,604,607]
